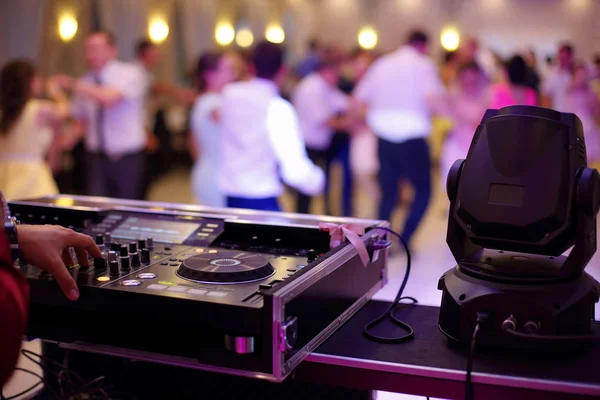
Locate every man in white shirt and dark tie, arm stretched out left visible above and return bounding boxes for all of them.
[57,31,148,199]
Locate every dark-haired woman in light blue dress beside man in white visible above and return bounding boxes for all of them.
[190,52,239,207]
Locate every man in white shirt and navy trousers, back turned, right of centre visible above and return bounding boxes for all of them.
[353,32,443,247]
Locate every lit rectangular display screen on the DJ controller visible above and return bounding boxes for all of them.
[112,217,200,244]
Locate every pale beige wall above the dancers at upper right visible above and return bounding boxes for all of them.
[298,0,600,60]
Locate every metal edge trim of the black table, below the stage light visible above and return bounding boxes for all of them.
[305,353,600,396]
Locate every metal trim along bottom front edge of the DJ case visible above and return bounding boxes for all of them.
[49,340,280,382]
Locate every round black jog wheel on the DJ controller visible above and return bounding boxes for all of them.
[177,251,275,284]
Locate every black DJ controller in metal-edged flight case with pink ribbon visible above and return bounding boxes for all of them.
[9,196,389,381]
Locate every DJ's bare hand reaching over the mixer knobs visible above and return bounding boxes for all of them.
[17,225,102,300]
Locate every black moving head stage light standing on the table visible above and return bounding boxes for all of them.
[438,106,600,349]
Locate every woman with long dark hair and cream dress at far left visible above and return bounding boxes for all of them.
[0,60,69,199]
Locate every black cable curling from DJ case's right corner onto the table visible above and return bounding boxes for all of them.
[363,227,418,343]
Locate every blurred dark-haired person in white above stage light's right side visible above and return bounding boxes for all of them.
[542,43,575,112]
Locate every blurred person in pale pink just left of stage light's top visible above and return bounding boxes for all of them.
[440,61,491,191]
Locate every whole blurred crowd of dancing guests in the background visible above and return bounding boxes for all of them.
[0,30,600,247]
